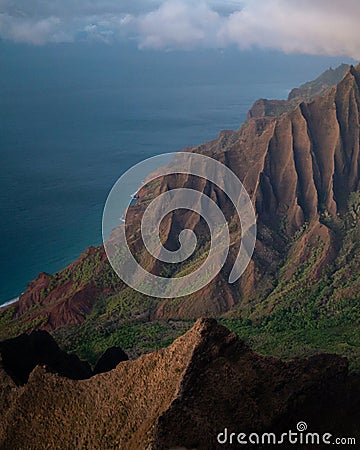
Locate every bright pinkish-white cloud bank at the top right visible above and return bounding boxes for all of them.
[219,0,360,59]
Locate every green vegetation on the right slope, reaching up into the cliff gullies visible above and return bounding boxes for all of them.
[220,192,360,371]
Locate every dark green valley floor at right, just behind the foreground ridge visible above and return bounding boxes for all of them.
[220,298,360,371]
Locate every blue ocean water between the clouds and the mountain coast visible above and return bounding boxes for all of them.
[0,42,346,304]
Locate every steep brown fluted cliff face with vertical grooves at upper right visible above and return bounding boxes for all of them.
[217,67,360,229]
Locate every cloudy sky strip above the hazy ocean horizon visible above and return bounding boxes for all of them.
[0,0,360,60]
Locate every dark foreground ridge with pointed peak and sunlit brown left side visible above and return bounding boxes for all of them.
[0,319,360,450]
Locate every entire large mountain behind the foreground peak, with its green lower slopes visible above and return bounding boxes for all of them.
[0,65,360,366]
